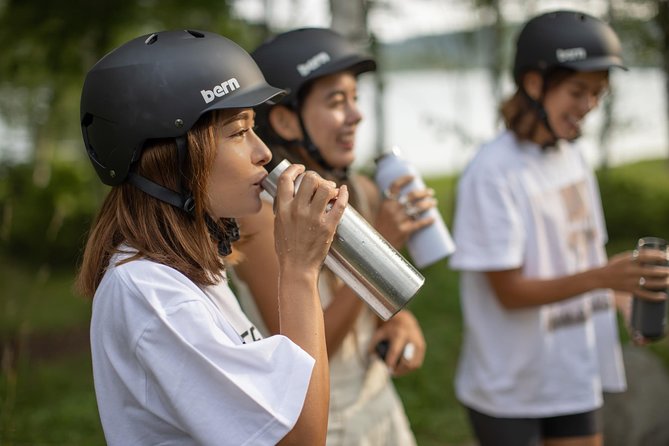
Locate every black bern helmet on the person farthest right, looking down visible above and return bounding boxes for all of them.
[513,11,627,85]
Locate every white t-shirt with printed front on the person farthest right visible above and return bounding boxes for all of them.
[450,132,625,417]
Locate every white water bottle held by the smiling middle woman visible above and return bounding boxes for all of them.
[374,147,455,268]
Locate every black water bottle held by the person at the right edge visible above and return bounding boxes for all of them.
[631,237,669,341]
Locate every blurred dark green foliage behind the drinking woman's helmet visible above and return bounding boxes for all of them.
[0,0,262,265]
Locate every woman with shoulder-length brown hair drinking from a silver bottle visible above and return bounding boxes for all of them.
[77,30,348,446]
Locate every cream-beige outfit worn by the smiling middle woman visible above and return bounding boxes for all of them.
[230,174,416,446]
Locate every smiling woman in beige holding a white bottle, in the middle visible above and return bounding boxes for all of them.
[234,28,428,446]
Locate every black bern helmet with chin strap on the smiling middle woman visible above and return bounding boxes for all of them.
[251,28,376,170]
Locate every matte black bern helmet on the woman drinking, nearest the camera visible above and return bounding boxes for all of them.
[81,30,283,210]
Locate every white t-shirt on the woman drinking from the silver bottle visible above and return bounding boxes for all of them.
[91,256,314,446]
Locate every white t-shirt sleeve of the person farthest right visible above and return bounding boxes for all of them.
[450,161,525,271]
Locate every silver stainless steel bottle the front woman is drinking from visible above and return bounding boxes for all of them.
[262,160,425,321]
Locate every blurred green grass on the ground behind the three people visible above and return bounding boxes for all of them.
[0,161,669,446]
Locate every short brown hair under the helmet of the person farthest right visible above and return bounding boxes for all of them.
[500,68,574,141]
